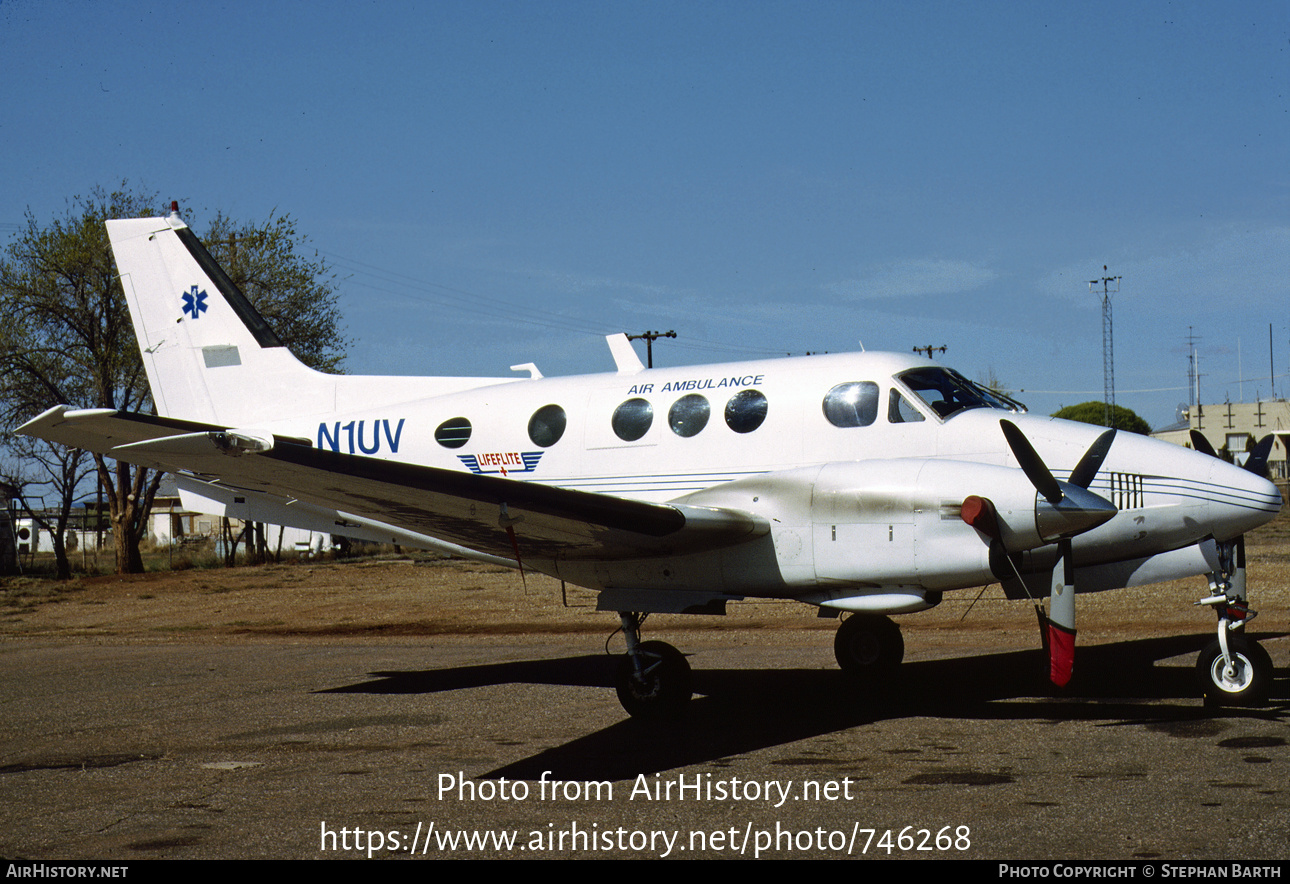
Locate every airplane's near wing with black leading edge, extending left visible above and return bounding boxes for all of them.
[15,405,770,560]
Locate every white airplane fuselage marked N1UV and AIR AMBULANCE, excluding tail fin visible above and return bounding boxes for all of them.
[243,354,1280,596]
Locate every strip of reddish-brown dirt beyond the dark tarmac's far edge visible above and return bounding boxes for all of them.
[0,512,1290,666]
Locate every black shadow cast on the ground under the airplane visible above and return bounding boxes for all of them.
[323,635,1290,781]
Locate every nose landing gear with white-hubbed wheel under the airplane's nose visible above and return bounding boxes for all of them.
[1196,537,1272,706]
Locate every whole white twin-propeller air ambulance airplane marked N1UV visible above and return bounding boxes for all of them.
[18,206,1281,716]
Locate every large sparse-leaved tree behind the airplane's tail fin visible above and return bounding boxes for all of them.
[0,182,346,573]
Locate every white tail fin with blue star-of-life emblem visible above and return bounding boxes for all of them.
[107,210,335,423]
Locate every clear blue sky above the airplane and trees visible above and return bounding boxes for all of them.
[0,0,1290,426]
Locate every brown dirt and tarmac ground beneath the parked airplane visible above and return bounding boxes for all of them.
[0,505,1290,859]
